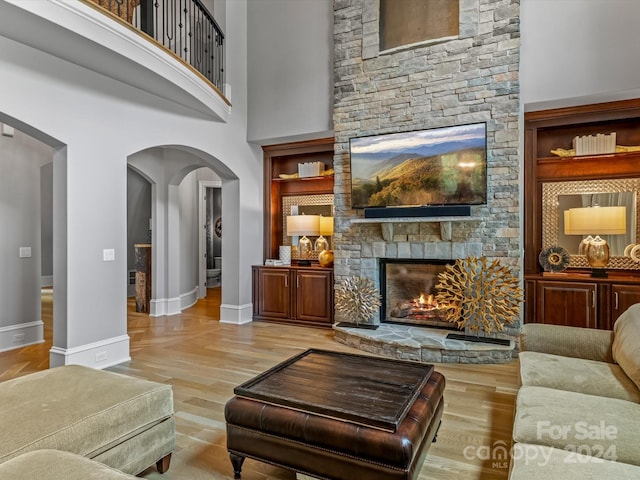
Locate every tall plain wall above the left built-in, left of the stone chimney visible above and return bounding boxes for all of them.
[246,0,333,145]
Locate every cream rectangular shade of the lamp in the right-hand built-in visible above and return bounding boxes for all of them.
[564,207,627,235]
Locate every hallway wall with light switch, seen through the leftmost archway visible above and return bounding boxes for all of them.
[0,130,53,351]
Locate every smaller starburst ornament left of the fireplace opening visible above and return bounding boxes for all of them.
[335,277,381,324]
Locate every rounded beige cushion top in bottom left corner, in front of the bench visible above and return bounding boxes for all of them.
[0,450,137,480]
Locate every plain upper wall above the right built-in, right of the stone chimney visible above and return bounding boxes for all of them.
[520,0,640,110]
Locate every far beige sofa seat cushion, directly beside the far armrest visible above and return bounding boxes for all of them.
[519,352,640,403]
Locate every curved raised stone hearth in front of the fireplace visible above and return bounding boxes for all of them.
[333,323,515,363]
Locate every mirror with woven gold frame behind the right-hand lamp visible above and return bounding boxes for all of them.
[542,179,640,269]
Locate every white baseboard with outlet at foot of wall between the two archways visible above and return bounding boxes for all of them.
[49,335,131,369]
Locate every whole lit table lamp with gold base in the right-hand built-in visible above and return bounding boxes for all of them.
[564,206,627,277]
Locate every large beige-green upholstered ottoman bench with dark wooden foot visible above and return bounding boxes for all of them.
[0,365,175,474]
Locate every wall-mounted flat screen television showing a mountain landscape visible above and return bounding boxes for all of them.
[349,123,487,208]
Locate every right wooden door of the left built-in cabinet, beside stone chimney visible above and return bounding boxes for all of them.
[296,270,333,325]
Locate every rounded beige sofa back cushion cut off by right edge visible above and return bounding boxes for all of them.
[612,303,640,388]
